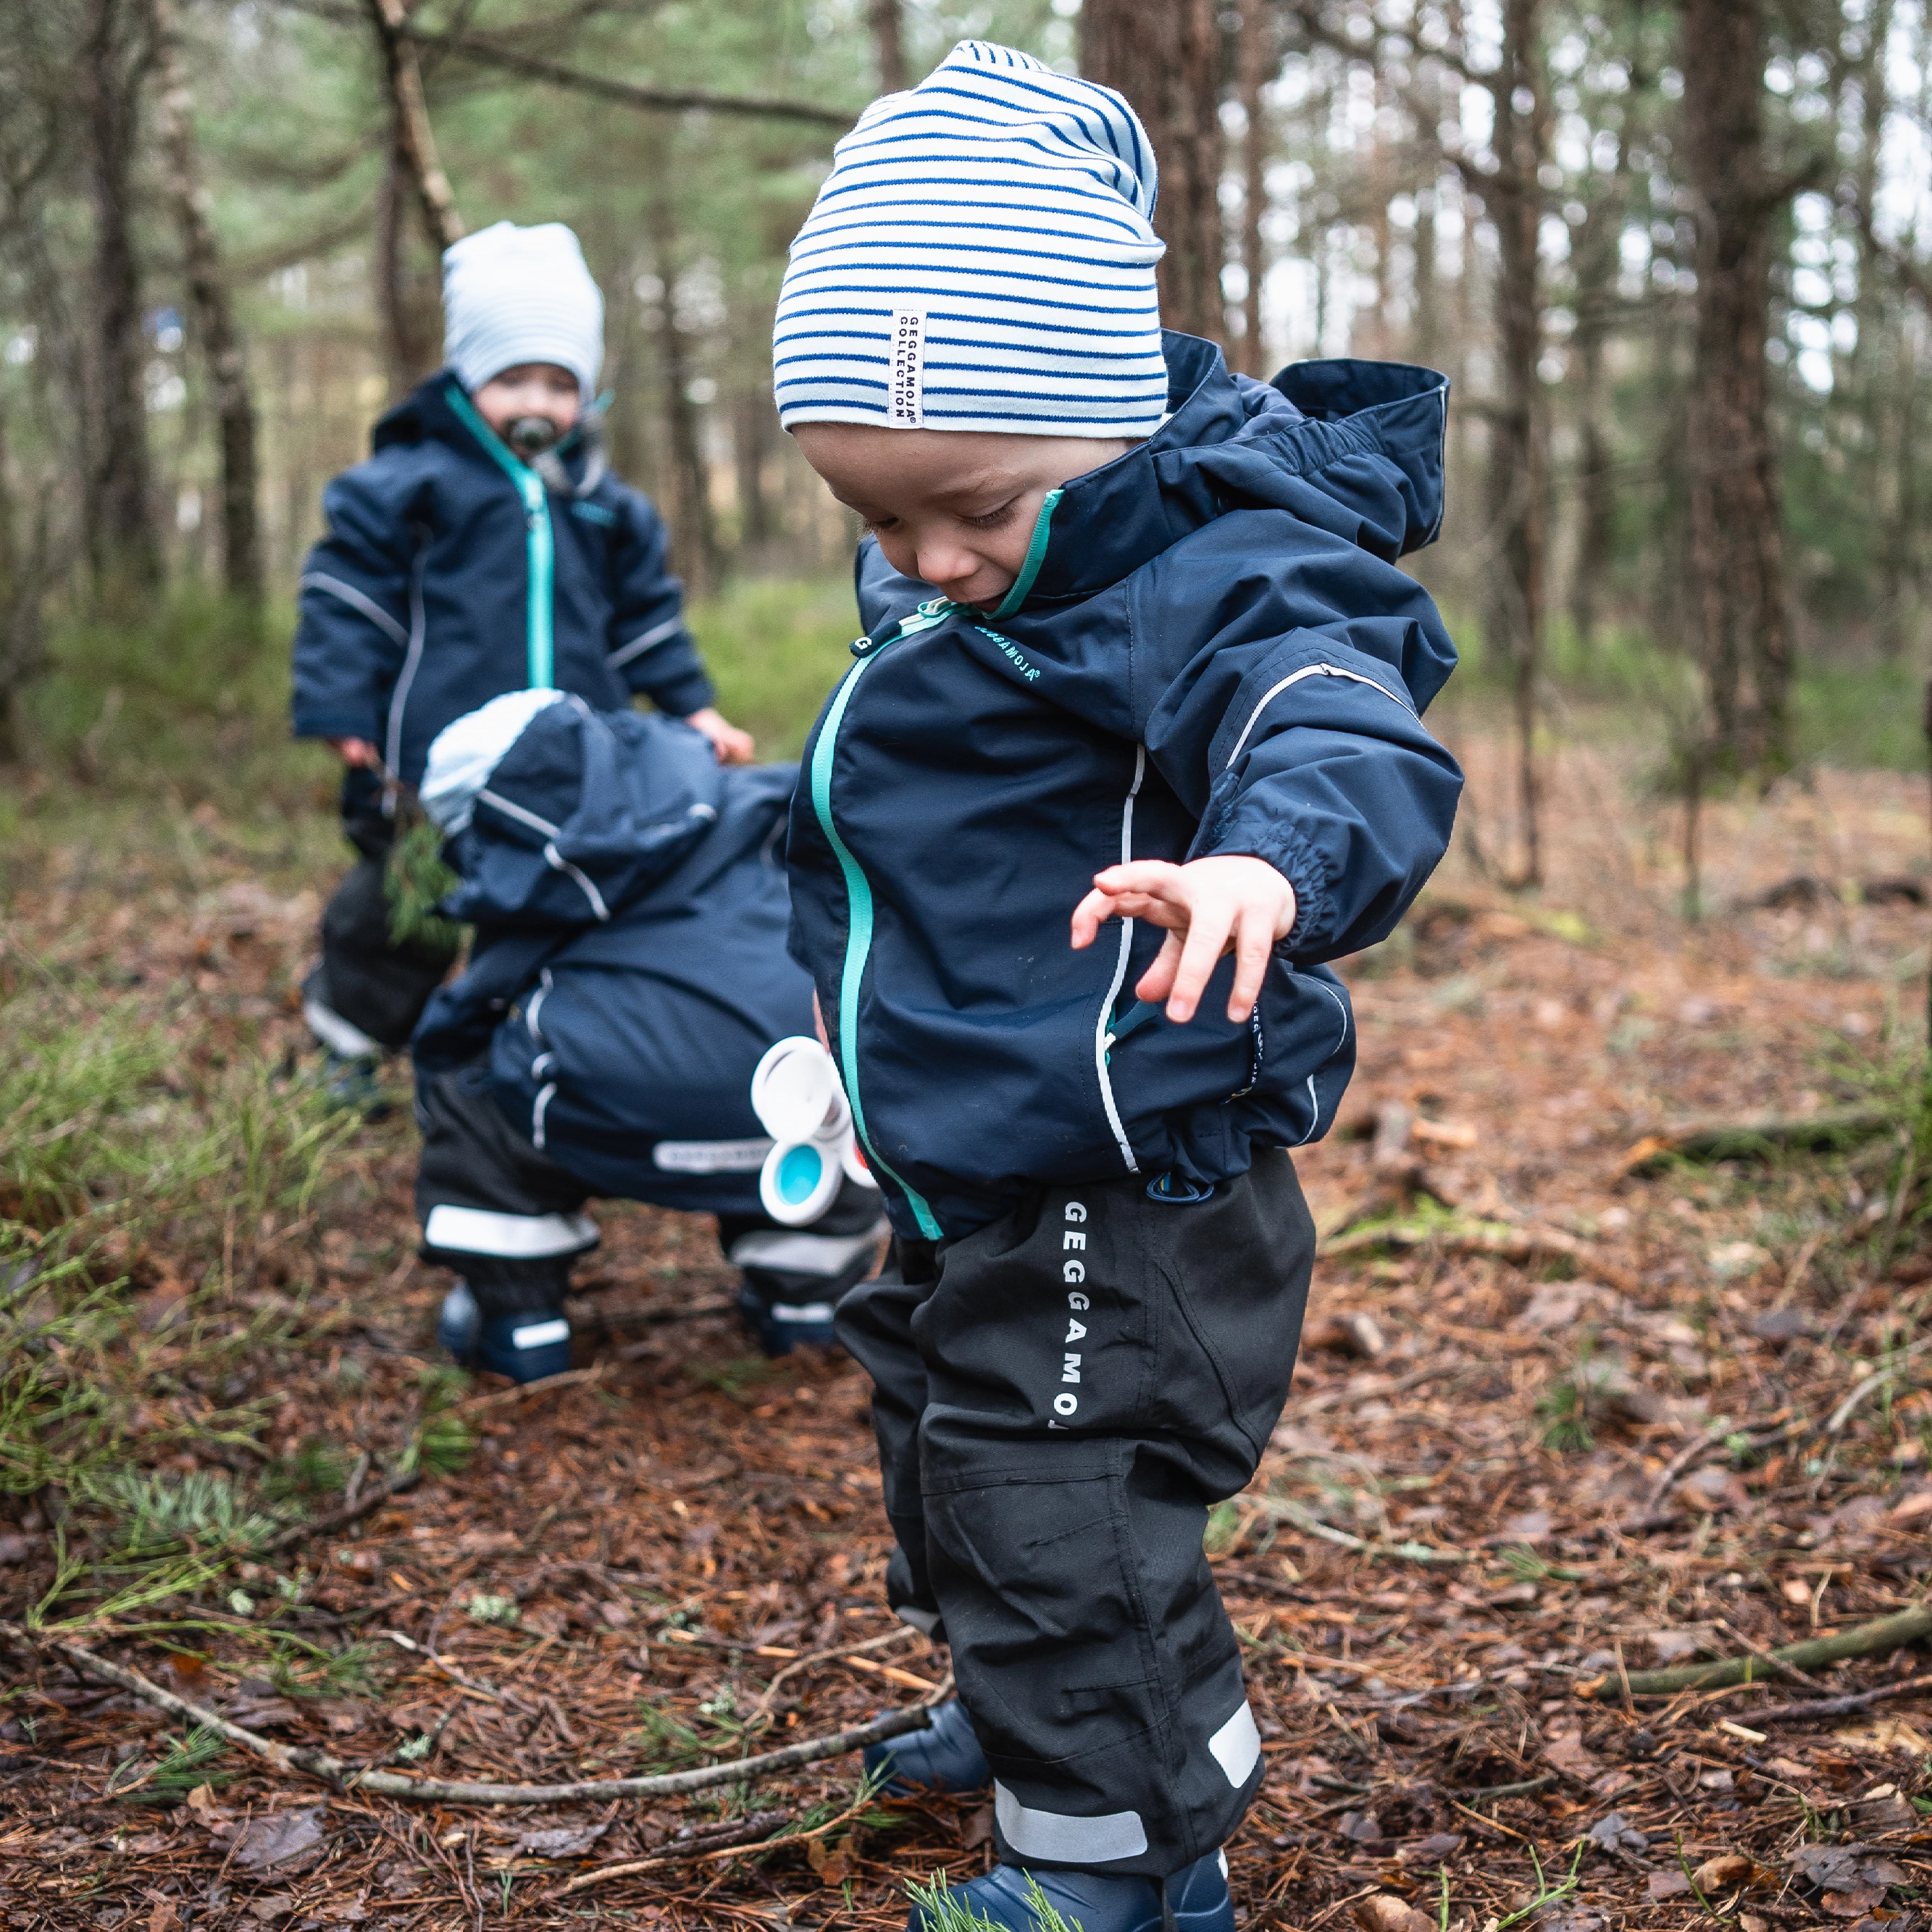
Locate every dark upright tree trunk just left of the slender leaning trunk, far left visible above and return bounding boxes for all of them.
[75,0,160,589]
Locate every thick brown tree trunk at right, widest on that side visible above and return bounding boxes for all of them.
[1683,0,1791,773]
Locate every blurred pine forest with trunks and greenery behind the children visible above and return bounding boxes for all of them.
[0,0,1932,883]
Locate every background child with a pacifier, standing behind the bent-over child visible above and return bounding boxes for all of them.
[293,222,751,1103]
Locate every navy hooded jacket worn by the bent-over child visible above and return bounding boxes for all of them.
[409,703,811,1213]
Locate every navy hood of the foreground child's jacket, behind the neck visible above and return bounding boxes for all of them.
[1008,330,1449,614]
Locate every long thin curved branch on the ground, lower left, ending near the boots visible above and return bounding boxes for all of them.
[0,1619,950,1805]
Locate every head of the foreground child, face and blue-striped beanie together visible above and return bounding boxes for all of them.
[773,41,1169,605]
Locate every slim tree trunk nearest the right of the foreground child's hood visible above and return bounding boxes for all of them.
[1474,0,1546,887]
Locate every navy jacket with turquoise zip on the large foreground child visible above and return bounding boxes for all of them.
[786,334,1460,1239]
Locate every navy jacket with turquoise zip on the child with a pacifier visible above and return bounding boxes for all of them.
[293,369,711,785]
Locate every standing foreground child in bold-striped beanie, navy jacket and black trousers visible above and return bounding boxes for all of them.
[774,41,1460,1932]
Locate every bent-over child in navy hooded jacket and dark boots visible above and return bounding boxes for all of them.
[411,692,885,1381]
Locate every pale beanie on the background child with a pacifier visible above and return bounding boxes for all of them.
[443,222,603,402]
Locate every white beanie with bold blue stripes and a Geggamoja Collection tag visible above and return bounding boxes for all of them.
[773,41,1167,437]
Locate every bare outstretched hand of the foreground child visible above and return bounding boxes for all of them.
[1072,854,1295,1026]
